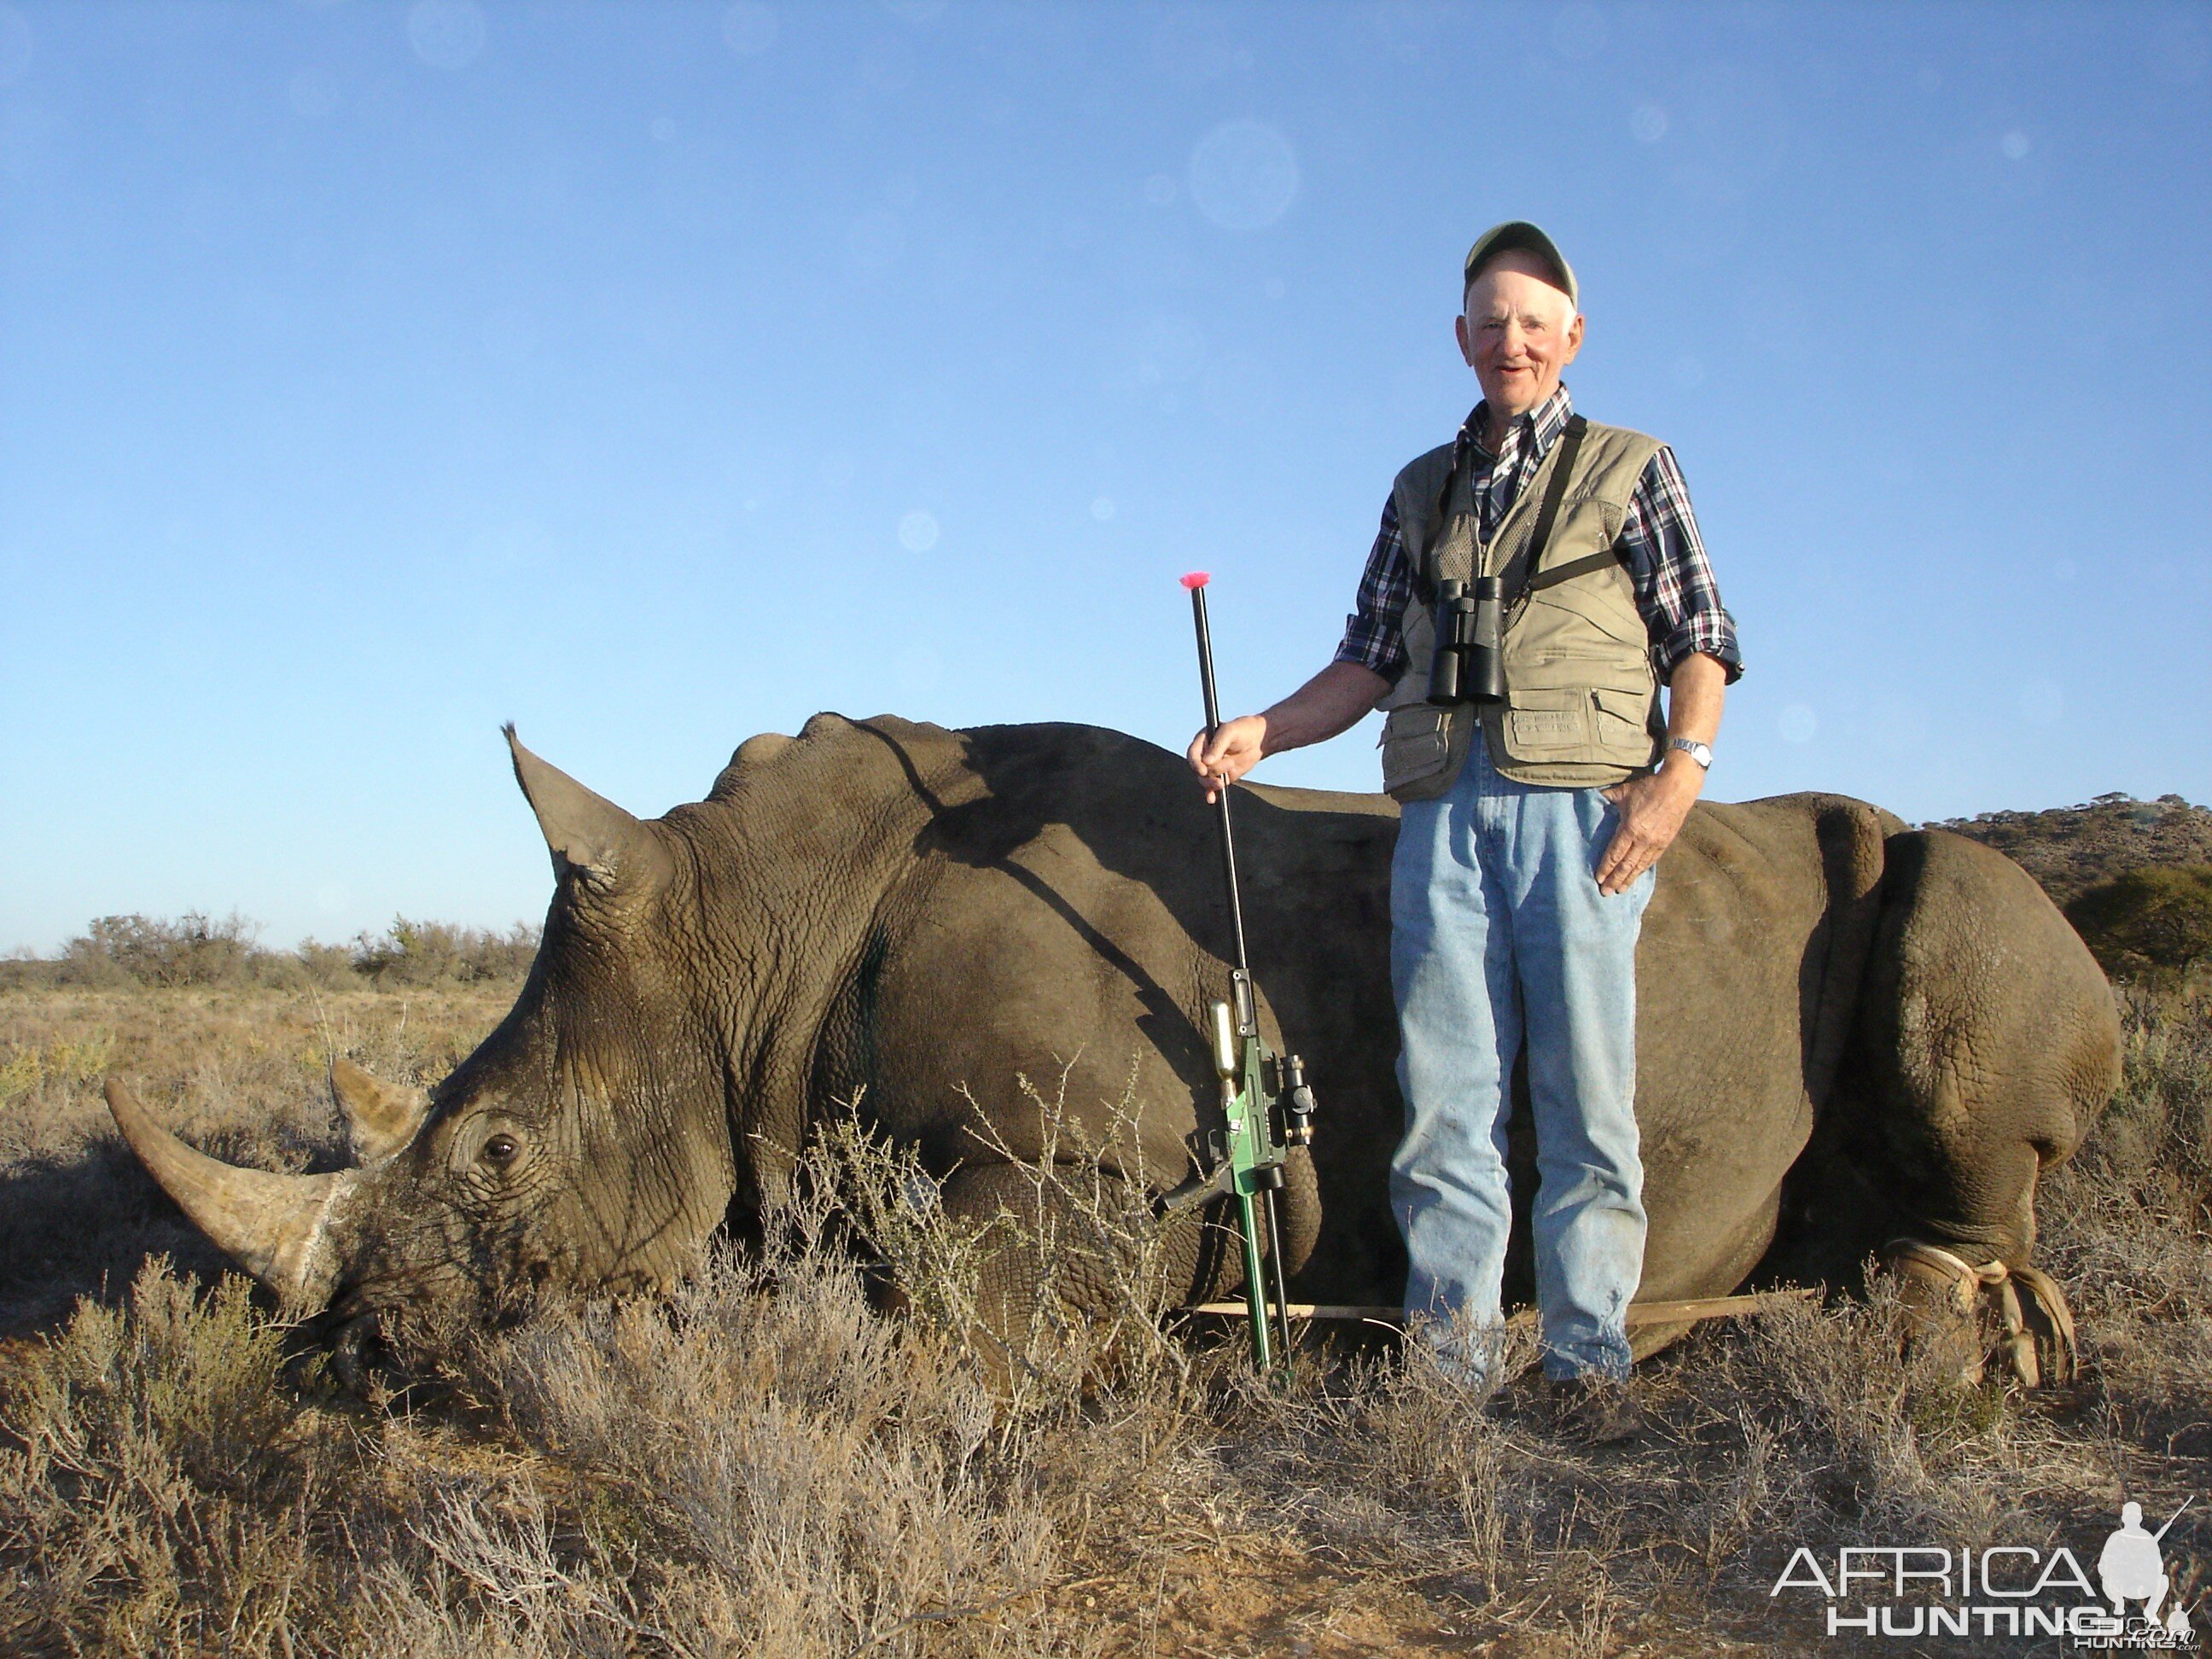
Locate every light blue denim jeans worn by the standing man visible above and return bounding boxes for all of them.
[1389,732,1655,1380]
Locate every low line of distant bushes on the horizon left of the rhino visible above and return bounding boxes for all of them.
[0,911,538,989]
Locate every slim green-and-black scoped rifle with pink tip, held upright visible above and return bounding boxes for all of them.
[1184,571,1314,1371]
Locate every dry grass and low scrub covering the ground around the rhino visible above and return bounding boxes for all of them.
[0,987,2212,1659]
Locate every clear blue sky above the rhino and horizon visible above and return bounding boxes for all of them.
[0,0,2212,949]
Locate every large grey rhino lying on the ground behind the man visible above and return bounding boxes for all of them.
[108,714,2119,1380]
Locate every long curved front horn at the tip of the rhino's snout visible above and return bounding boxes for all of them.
[106,1077,360,1318]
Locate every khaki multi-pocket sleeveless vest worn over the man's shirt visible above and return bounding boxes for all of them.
[1376,420,1666,800]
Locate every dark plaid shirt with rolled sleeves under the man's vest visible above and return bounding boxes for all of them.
[1336,385,1743,684]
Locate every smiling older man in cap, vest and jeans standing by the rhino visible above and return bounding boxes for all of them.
[1190,221,1743,1416]
